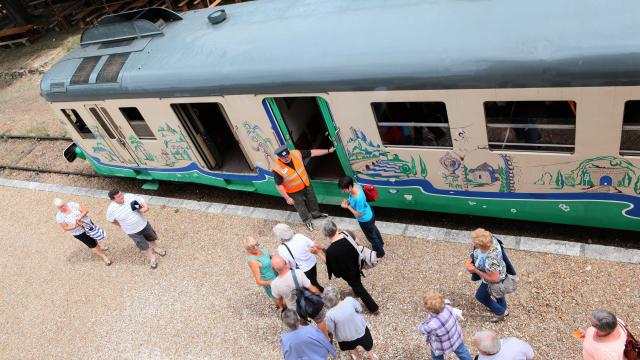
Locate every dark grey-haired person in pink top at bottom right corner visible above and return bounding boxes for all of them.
[582,310,627,360]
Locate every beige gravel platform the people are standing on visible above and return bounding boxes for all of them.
[0,187,640,359]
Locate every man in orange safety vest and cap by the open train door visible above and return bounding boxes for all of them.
[272,144,336,231]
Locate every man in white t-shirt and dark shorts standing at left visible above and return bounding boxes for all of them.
[107,189,167,269]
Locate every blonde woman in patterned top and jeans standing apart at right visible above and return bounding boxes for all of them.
[466,229,509,322]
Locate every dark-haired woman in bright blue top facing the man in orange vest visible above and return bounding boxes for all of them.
[338,176,384,258]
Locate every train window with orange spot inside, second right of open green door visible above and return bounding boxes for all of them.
[484,101,576,153]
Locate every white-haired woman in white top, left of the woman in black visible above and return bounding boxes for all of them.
[273,224,324,292]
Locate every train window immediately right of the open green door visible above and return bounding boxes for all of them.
[371,102,452,148]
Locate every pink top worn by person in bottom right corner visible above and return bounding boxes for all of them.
[582,325,627,360]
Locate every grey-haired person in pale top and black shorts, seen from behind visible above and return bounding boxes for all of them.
[322,287,378,360]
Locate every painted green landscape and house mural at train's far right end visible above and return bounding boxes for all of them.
[534,156,640,195]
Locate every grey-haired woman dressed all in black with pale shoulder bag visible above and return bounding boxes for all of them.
[322,220,378,313]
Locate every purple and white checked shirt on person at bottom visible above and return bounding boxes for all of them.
[418,305,464,355]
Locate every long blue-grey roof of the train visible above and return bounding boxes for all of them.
[41,0,640,101]
